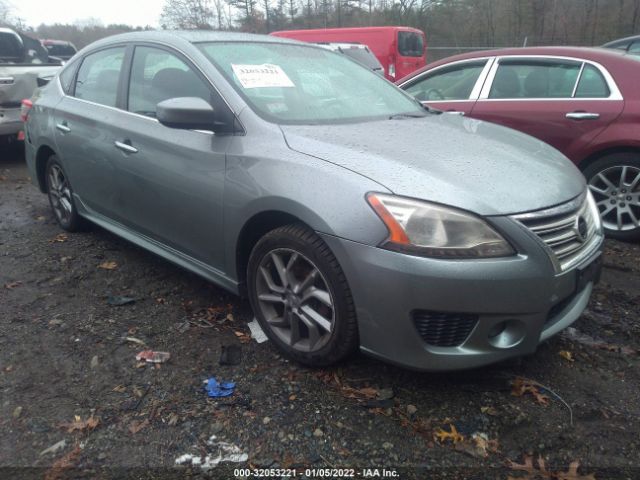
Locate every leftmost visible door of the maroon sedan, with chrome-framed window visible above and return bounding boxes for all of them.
[400,58,493,115]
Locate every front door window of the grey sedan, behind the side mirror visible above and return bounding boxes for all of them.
[128,47,211,118]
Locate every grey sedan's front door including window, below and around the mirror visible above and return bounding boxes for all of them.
[110,44,233,270]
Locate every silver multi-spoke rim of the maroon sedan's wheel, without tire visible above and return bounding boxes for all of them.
[589,165,640,231]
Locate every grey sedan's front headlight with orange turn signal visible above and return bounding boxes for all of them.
[367,193,515,258]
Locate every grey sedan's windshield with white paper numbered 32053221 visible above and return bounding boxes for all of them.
[198,42,425,124]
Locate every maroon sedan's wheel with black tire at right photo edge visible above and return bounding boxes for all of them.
[583,152,640,241]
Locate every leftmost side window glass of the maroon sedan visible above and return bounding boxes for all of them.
[406,60,487,102]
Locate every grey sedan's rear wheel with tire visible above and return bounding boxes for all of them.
[45,155,87,232]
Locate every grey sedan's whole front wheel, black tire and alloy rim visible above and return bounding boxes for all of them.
[247,224,359,367]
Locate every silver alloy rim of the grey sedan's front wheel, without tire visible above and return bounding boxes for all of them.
[256,248,335,352]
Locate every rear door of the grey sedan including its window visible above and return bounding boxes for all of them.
[54,46,127,217]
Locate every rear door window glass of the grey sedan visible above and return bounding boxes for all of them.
[75,47,125,107]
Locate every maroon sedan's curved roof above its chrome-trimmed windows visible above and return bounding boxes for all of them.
[396,47,635,83]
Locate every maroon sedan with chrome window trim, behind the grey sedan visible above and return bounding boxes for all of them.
[398,47,640,240]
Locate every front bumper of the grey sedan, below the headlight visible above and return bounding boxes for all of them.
[322,218,603,371]
